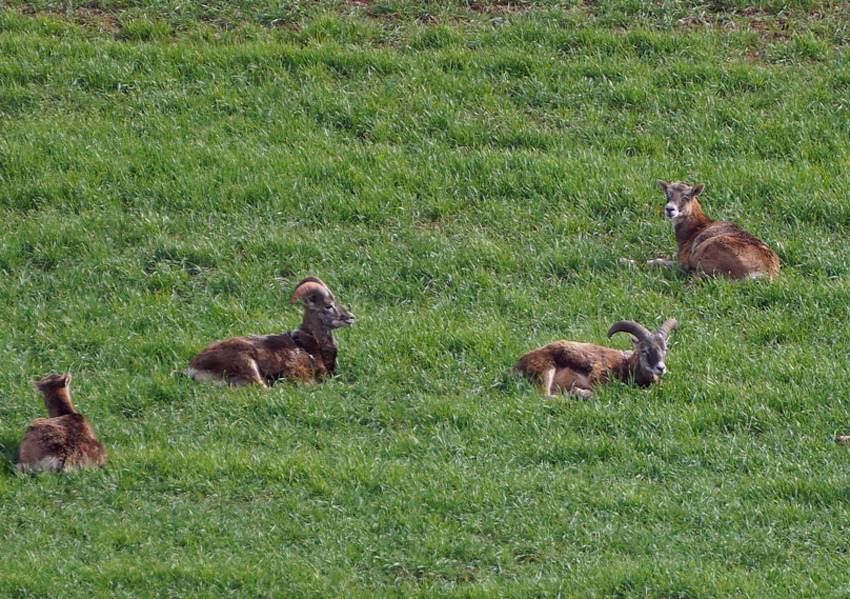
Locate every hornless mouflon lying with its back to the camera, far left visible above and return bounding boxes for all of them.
[16,374,106,472]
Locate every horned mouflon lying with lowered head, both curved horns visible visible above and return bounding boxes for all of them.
[516,318,679,399]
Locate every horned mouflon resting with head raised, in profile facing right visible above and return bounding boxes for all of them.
[187,277,354,387]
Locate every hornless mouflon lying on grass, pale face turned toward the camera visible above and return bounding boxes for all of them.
[649,180,779,279]
